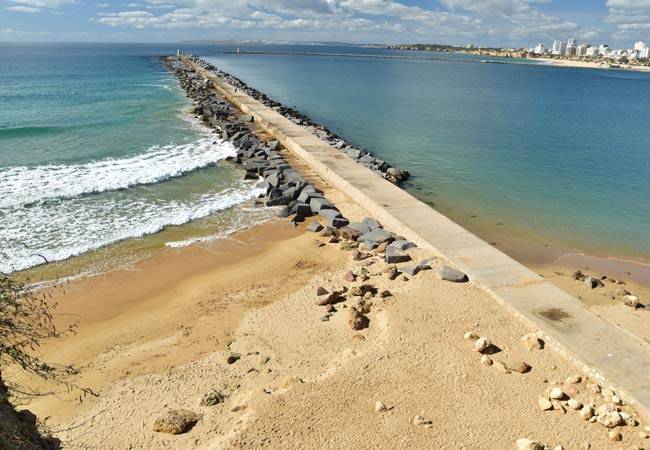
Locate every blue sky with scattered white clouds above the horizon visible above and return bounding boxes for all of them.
[0,0,650,48]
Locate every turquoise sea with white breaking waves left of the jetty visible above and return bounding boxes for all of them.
[0,44,268,271]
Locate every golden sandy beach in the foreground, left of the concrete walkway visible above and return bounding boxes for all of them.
[13,191,643,450]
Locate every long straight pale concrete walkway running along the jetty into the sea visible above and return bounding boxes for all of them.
[178,58,650,420]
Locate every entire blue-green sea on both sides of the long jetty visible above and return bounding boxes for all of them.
[0,43,650,271]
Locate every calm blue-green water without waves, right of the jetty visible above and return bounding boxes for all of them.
[207,47,650,257]
